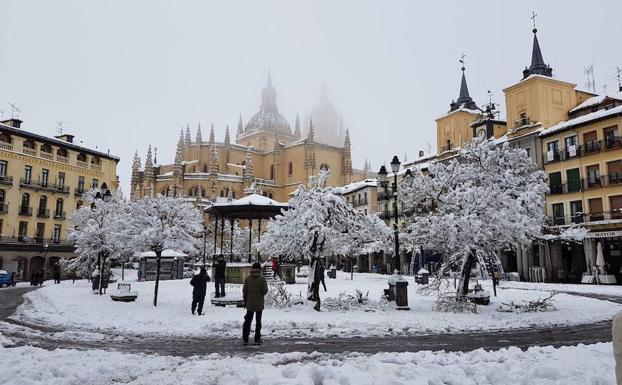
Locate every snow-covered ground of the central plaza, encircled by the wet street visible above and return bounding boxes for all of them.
[12,273,622,337]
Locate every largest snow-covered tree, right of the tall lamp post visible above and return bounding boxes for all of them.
[399,139,548,299]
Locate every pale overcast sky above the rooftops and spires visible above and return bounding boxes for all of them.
[0,0,622,194]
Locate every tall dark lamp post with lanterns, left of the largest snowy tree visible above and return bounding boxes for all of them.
[378,155,410,310]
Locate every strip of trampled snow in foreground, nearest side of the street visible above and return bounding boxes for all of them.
[0,335,615,385]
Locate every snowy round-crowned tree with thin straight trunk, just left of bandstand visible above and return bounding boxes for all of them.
[117,195,203,306]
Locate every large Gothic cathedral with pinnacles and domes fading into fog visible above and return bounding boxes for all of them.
[131,75,365,203]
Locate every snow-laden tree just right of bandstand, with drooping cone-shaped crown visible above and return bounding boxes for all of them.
[257,171,388,310]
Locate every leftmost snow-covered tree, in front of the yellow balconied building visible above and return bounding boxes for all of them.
[66,189,127,294]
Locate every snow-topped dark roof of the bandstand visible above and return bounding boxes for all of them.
[205,194,289,219]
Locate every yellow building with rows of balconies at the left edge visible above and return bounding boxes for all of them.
[0,119,119,279]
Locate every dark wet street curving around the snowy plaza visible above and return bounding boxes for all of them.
[0,288,622,356]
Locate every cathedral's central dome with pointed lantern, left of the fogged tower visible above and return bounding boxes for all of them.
[244,74,292,136]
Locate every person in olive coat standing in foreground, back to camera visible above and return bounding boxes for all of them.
[242,262,268,345]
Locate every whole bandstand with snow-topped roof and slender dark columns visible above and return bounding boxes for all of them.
[205,193,289,263]
